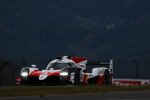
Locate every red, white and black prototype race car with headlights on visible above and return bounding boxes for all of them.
[16,56,113,85]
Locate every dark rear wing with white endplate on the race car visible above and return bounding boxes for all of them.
[86,59,113,73]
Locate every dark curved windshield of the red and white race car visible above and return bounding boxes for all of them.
[46,62,76,70]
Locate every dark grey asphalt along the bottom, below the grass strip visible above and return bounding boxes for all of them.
[0,91,150,100]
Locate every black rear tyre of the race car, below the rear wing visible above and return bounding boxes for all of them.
[104,70,112,86]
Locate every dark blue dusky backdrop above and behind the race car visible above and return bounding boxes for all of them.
[0,0,150,77]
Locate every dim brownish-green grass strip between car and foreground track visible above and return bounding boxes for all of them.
[0,85,150,97]
